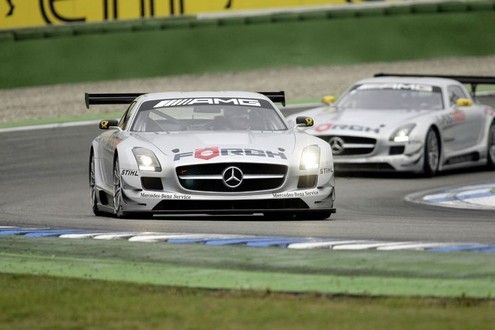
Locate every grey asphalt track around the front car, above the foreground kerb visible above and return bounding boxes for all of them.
[0,125,495,244]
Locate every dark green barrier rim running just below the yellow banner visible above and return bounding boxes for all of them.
[0,0,495,42]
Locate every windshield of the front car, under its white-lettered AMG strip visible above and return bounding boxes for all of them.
[131,98,287,132]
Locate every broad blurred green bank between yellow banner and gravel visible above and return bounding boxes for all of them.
[0,11,495,89]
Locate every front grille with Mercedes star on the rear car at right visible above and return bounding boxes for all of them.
[320,135,376,157]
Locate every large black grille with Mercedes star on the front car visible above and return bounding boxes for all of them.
[176,163,287,192]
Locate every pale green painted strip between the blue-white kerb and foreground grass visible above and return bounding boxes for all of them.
[0,236,495,298]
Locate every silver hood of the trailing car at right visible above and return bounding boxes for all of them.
[307,109,431,135]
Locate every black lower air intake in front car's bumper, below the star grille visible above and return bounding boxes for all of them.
[153,198,309,213]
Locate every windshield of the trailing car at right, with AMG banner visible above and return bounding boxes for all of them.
[337,83,443,110]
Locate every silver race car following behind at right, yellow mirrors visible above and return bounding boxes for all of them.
[289,74,495,176]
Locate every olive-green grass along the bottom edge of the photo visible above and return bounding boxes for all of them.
[0,274,495,330]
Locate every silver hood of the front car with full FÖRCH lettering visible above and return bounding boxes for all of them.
[134,131,296,161]
